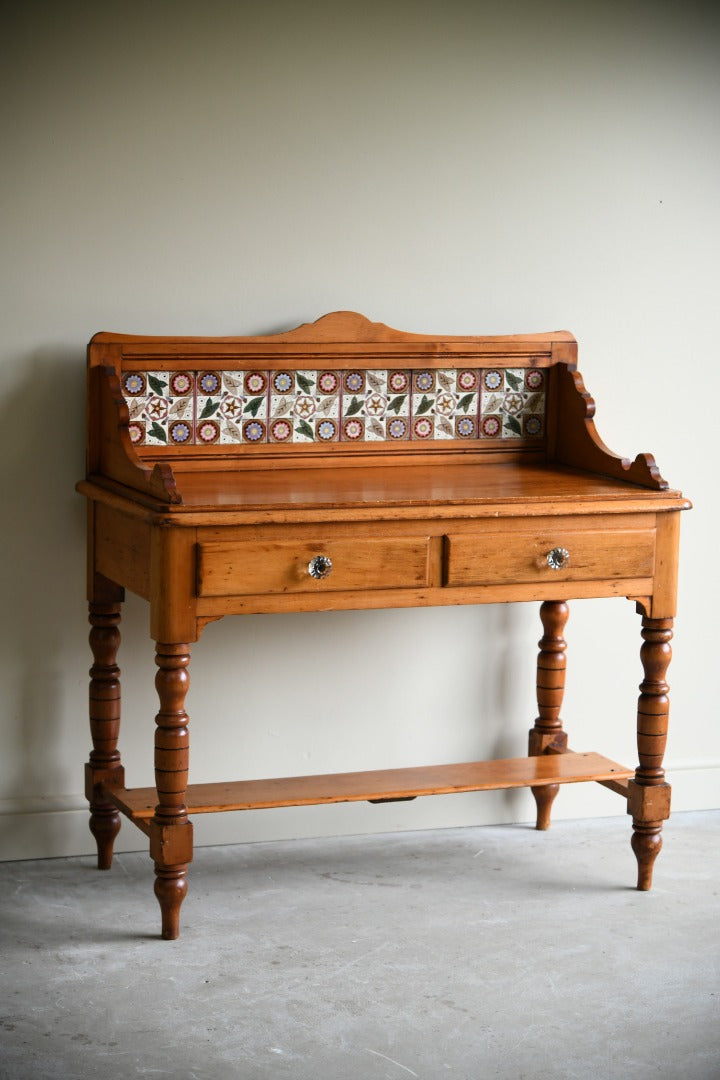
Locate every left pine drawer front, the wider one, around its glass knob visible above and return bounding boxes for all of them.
[198,537,430,596]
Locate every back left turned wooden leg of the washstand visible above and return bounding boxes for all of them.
[85,603,125,870]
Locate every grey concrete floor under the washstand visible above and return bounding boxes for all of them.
[0,811,720,1080]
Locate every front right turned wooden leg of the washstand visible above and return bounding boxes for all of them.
[627,618,673,891]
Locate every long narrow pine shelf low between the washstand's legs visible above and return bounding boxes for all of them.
[105,753,635,827]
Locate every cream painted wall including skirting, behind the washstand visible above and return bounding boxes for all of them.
[0,0,720,859]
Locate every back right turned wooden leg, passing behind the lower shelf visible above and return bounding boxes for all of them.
[528,600,570,829]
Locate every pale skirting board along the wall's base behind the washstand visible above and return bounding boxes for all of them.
[0,761,720,862]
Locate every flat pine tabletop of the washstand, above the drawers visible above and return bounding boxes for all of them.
[81,462,688,524]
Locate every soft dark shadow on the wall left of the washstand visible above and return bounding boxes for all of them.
[0,347,85,812]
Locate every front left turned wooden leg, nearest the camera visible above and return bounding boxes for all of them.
[150,644,192,940]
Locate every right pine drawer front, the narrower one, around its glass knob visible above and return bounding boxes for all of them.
[445,529,655,585]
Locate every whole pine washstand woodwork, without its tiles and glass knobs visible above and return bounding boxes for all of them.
[78,312,690,937]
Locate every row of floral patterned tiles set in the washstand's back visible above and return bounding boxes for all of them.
[122,367,546,446]
